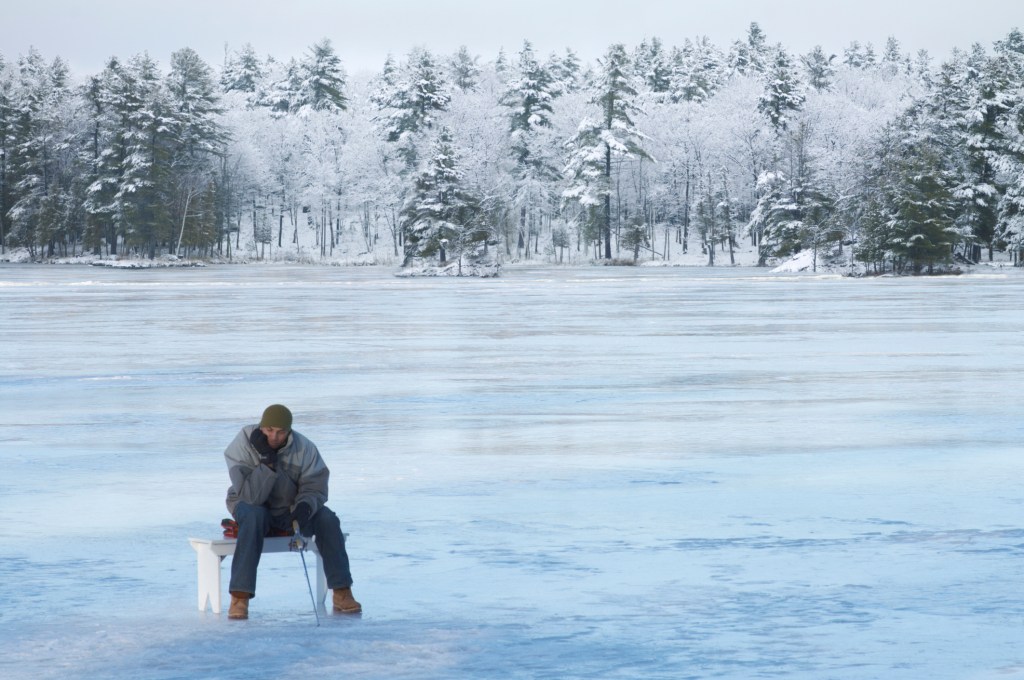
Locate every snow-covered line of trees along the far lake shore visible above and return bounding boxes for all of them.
[0,24,1024,273]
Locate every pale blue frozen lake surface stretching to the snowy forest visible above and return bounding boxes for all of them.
[0,265,1024,680]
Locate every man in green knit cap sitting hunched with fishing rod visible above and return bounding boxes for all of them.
[224,403,362,619]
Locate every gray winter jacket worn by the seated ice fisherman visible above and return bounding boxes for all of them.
[224,425,331,515]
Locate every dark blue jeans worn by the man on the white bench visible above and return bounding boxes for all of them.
[227,503,352,595]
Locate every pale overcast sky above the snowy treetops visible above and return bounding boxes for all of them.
[0,0,1024,76]
